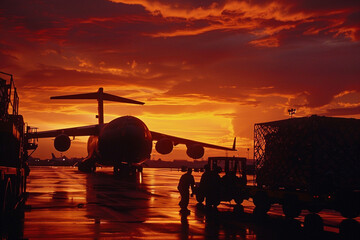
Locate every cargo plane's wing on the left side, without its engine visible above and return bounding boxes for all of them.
[27,124,99,138]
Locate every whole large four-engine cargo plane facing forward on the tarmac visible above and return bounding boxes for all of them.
[27,88,236,173]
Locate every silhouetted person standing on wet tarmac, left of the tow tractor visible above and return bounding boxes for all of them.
[178,168,195,212]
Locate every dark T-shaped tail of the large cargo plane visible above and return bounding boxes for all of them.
[50,88,144,124]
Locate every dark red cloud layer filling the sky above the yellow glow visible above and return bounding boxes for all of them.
[0,0,360,114]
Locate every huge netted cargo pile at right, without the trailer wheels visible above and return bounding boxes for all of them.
[255,116,360,193]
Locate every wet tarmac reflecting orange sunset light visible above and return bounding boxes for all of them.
[1,167,360,240]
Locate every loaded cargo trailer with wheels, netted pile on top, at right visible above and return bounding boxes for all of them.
[249,115,360,218]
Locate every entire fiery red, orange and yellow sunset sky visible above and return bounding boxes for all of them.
[0,0,360,159]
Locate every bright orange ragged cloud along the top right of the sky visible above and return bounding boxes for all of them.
[113,0,359,41]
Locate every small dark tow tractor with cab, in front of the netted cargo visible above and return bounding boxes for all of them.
[194,157,249,206]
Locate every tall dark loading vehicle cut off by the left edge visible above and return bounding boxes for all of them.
[0,72,37,215]
